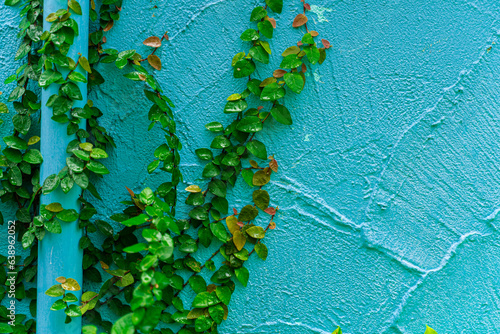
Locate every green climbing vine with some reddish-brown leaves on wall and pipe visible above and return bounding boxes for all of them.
[0,0,438,334]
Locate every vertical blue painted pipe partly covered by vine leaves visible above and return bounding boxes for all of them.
[37,0,89,334]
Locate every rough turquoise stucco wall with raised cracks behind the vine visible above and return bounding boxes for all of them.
[0,0,500,334]
